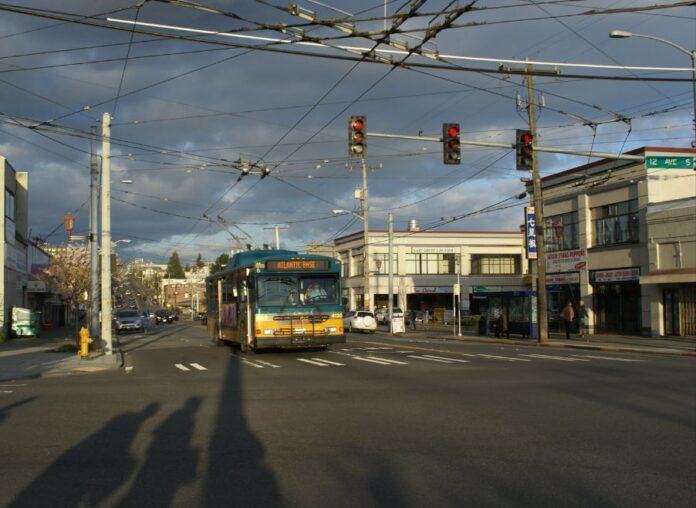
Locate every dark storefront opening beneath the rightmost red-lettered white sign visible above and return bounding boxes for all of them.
[590,267,642,335]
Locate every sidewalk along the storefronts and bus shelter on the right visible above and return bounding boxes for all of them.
[406,324,696,357]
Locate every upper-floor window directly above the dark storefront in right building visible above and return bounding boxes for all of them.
[592,199,640,247]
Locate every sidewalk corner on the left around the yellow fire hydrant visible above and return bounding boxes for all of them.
[0,327,122,381]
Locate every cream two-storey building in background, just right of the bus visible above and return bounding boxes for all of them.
[334,228,529,320]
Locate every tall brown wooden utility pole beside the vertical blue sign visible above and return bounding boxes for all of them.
[525,64,549,344]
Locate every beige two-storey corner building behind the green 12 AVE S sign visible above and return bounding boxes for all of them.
[542,148,696,337]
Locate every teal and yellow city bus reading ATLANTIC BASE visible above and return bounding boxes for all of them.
[206,250,346,352]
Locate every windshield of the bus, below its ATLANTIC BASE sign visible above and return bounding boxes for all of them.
[256,275,338,307]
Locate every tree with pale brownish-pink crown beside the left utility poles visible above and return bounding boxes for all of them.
[39,245,90,346]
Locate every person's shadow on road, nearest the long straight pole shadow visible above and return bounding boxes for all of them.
[117,397,201,508]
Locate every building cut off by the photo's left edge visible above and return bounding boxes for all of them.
[0,156,29,336]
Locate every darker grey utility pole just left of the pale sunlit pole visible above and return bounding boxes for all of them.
[89,126,100,339]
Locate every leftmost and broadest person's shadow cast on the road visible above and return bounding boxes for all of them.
[7,402,159,508]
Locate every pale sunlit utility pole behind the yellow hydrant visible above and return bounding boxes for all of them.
[101,113,113,355]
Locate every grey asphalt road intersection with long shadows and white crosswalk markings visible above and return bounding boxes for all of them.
[0,322,696,507]
